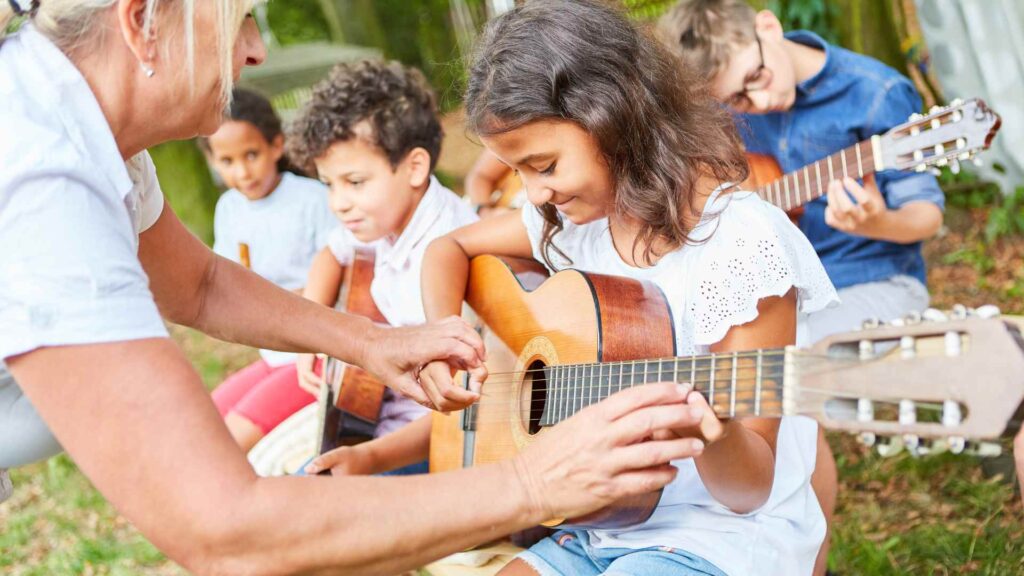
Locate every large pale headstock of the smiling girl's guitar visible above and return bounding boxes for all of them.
[784,306,1024,452]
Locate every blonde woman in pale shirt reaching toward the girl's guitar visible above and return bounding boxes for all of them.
[0,0,698,574]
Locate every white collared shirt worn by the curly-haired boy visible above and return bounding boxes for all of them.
[328,176,478,436]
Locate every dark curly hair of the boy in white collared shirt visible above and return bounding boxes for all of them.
[288,60,444,174]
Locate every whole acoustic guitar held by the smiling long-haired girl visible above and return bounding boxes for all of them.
[430,256,1024,528]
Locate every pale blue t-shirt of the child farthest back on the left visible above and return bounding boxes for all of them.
[213,172,338,367]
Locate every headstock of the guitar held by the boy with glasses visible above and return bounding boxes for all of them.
[876,98,1001,172]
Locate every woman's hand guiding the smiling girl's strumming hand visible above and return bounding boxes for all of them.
[361,316,484,410]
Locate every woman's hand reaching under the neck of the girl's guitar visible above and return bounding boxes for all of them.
[513,383,706,518]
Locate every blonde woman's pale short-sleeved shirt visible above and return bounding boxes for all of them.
[0,26,167,360]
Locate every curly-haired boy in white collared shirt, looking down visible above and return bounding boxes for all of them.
[287,60,477,474]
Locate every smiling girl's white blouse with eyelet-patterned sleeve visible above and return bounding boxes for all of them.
[522,191,838,575]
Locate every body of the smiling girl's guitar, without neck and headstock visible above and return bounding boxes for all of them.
[430,256,675,528]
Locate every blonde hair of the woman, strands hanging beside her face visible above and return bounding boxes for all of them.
[0,0,255,104]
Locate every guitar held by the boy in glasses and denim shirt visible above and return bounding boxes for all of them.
[746,98,1001,215]
